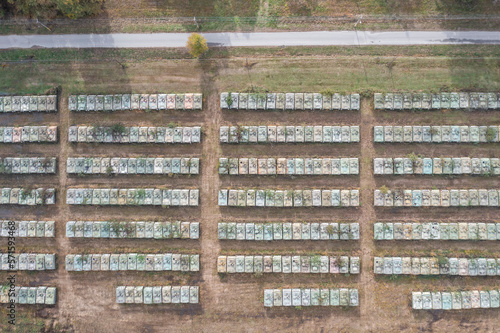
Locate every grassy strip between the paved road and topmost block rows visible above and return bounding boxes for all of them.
[0,45,500,95]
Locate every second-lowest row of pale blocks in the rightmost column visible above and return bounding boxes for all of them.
[373,257,500,276]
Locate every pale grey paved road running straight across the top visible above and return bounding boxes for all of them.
[0,31,500,49]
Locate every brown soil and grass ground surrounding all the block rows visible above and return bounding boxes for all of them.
[0,50,500,332]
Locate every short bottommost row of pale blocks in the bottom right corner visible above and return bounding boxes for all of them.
[411,290,500,310]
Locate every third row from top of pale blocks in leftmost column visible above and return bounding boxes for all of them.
[0,157,57,174]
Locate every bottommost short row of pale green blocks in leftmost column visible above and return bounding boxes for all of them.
[0,285,57,305]
